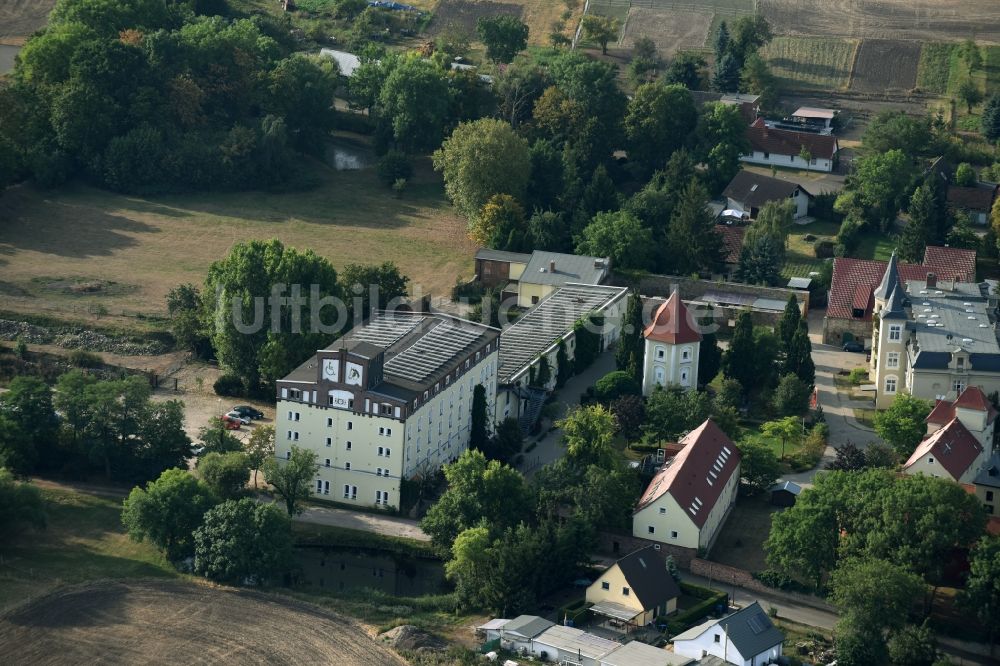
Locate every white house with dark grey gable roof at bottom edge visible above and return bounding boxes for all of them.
[673,601,785,666]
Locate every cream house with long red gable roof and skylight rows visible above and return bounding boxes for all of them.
[632,419,740,550]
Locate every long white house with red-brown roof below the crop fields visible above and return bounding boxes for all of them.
[740,118,840,172]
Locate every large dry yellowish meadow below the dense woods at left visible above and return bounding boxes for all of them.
[0,161,475,324]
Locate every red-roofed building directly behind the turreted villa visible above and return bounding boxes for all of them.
[823,246,976,348]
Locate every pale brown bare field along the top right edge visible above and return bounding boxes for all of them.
[758,0,1000,44]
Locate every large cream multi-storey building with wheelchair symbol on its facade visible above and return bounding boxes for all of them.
[275,312,500,507]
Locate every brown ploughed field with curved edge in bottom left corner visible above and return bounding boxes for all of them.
[0,581,405,666]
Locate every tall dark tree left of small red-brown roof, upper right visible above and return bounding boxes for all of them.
[667,180,722,275]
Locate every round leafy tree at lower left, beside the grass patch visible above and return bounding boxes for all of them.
[122,468,217,562]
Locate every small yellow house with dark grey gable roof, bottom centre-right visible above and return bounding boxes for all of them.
[587,546,681,629]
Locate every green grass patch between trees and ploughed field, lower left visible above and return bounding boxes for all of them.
[0,489,180,610]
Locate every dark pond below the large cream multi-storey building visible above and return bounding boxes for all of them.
[295,546,448,597]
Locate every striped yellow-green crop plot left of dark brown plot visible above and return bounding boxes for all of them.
[762,37,858,90]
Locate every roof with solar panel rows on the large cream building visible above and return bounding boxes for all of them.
[284,311,499,400]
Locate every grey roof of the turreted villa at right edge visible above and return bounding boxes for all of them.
[906,280,1000,371]
